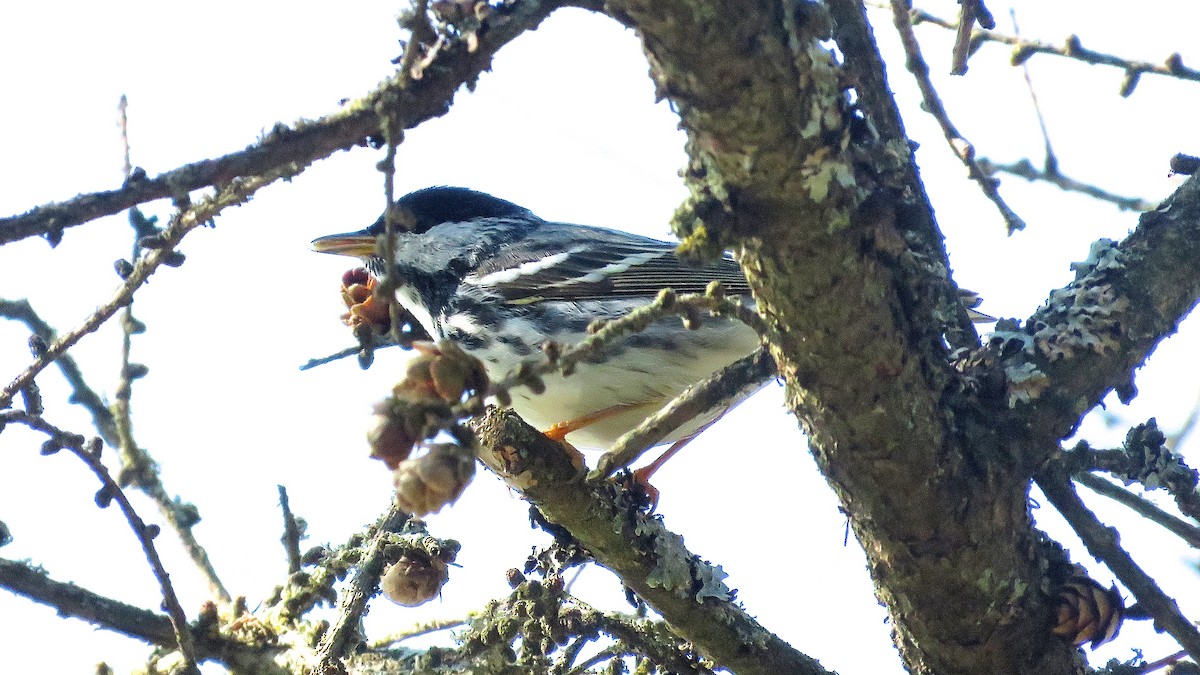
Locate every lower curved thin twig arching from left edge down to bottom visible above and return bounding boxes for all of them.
[0,411,199,674]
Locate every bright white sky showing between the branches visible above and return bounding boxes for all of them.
[0,0,1200,673]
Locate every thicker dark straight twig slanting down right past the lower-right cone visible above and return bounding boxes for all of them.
[1037,467,1200,659]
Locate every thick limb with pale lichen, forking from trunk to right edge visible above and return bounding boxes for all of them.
[990,177,1200,441]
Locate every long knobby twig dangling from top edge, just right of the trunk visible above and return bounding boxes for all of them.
[892,0,1025,234]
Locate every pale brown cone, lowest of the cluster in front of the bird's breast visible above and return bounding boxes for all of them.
[392,443,475,516]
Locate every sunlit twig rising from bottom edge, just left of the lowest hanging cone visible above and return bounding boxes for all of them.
[313,501,408,675]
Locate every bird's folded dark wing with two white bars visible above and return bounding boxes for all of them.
[463,223,750,304]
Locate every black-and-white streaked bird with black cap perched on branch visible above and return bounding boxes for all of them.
[312,186,773,484]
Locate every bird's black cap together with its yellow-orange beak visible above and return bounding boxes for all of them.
[312,185,533,258]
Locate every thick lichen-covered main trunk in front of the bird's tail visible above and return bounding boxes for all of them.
[611,0,1074,674]
